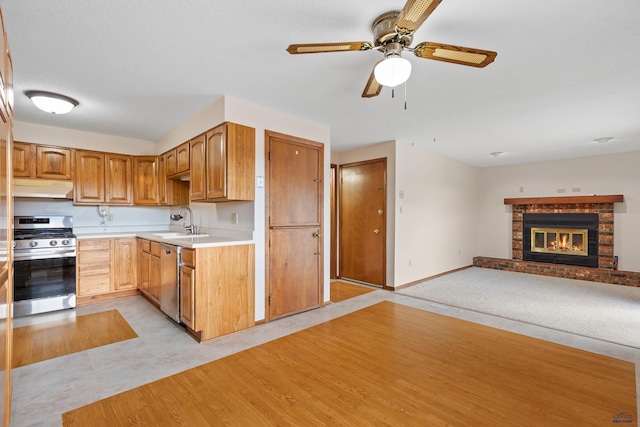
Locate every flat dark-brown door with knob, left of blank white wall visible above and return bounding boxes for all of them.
[338,159,387,286]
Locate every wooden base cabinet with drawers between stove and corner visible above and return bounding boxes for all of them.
[76,237,137,304]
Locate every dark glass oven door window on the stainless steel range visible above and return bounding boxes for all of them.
[13,257,76,301]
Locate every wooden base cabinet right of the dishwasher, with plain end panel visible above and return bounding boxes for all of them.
[180,244,255,341]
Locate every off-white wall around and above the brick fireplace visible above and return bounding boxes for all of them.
[477,151,640,271]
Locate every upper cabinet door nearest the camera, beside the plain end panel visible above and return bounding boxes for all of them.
[206,125,227,199]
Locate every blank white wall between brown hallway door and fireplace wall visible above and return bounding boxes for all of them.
[395,141,478,286]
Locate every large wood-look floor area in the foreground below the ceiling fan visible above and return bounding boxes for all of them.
[62,301,637,426]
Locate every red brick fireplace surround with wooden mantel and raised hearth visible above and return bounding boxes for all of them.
[473,195,640,287]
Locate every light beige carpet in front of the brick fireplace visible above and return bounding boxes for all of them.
[397,267,640,348]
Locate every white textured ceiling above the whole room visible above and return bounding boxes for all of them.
[0,0,640,166]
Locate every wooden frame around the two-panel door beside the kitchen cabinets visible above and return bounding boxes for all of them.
[264,129,325,323]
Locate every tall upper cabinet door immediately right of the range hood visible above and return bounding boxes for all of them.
[73,150,105,204]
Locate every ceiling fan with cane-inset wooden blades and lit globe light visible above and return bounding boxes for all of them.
[287,0,498,98]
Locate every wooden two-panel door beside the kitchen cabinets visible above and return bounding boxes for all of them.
[266,132,324,319]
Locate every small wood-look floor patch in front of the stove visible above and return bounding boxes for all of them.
[13,310,138,368]
